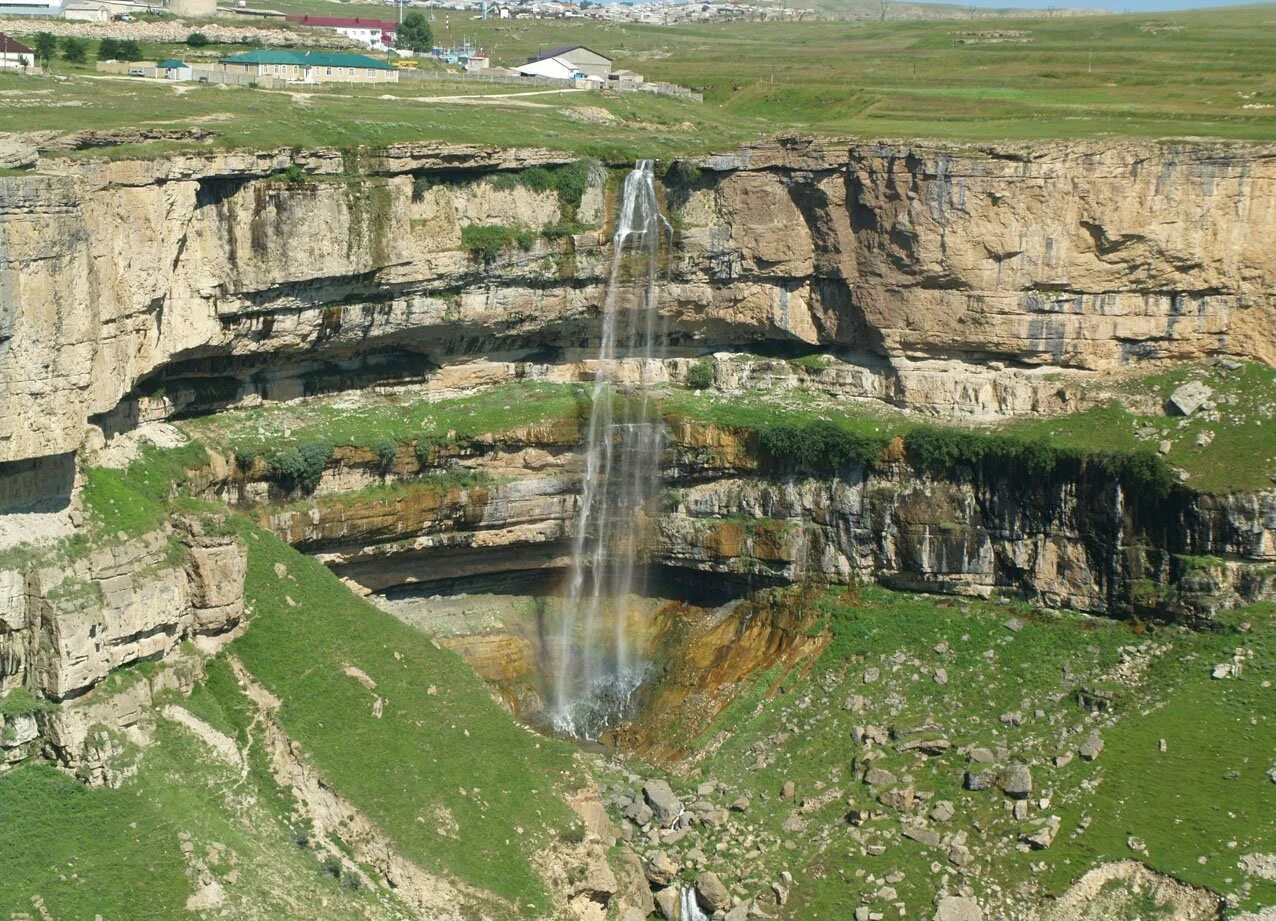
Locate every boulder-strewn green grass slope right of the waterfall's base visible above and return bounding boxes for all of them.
[622,588,1276,920]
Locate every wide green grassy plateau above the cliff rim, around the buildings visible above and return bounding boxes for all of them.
[0,5,1276,159]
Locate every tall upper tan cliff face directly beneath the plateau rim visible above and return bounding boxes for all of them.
[0,142,1276,492]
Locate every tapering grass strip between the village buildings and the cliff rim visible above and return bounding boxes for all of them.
[0,68,759,161]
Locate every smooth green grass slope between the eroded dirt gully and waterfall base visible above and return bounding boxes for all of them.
[232,529,581,916]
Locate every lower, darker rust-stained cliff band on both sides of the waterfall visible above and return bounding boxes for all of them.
[196,422,1276,621]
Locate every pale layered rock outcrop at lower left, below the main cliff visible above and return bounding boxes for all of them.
[0,522,246,781]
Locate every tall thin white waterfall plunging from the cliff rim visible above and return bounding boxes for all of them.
[550,159,672,739]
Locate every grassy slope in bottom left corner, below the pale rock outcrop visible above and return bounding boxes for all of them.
[0,666,407,921]
